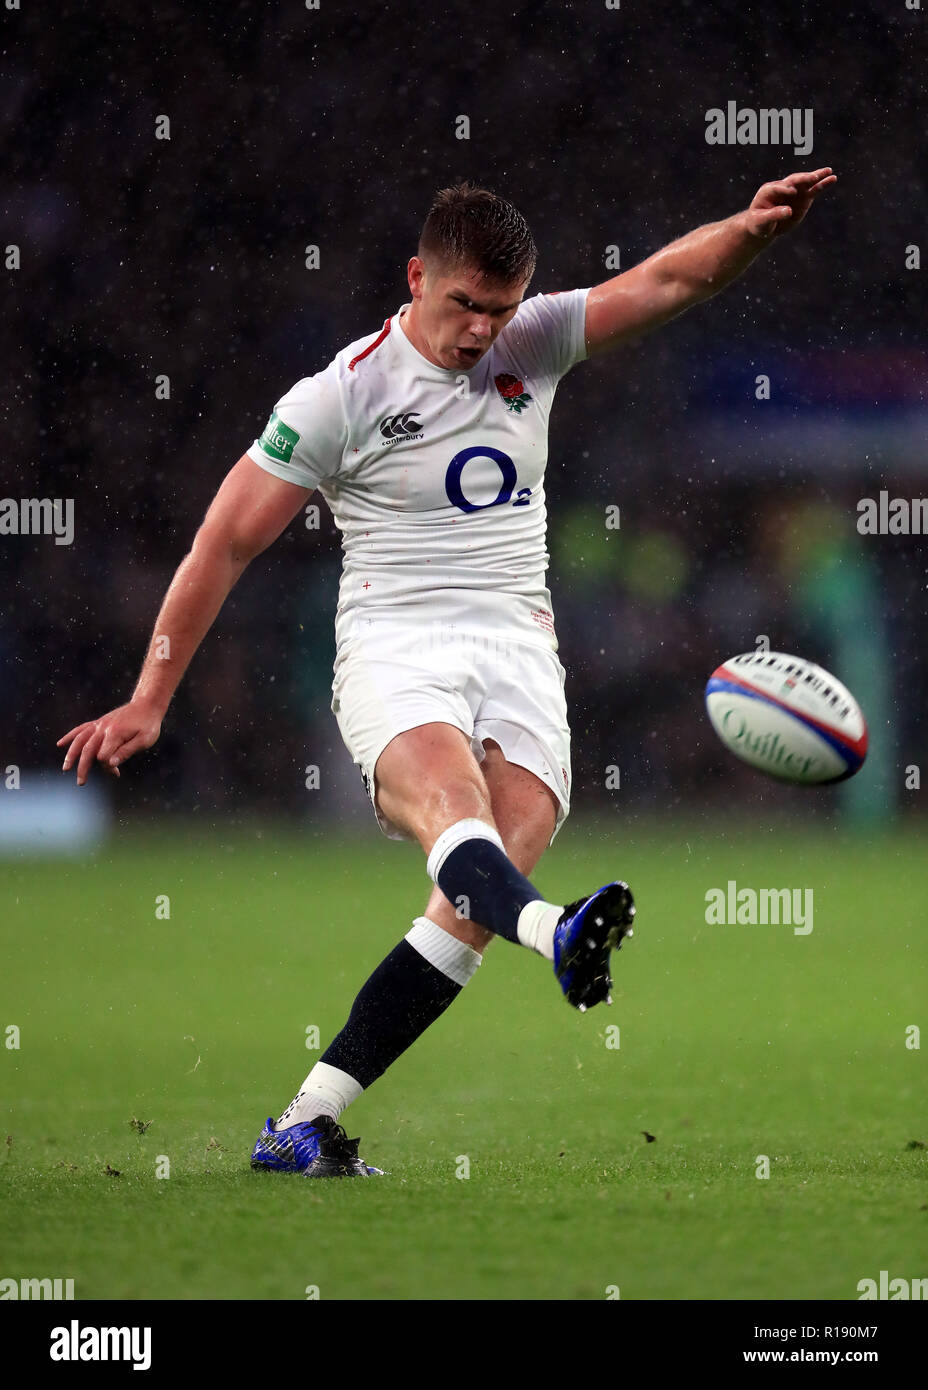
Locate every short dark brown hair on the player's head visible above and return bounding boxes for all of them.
[418,183,538,285]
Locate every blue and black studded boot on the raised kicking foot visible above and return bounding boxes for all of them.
[554,883,635,1013]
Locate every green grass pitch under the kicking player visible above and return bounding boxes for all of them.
[0,821,928,1300]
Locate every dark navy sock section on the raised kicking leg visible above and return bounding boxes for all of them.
[429,835,542,944]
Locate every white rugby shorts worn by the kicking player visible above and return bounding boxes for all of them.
[332,621,571,844]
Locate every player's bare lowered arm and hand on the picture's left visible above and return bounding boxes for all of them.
[57,455,314,787]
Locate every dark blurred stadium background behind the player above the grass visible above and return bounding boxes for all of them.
[0,0,928,824]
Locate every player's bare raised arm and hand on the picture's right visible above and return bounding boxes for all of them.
[586,168,836,357]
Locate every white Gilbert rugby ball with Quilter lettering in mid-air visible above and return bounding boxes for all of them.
[706,652,867,787]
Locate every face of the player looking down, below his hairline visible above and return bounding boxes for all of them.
[410,256,529,371]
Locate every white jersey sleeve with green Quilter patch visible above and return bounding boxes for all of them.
[246,361,347,488]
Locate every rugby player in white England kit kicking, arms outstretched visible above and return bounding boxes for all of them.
[58,168,835,1177]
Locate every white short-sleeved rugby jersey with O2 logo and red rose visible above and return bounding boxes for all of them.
[247,289,589,651]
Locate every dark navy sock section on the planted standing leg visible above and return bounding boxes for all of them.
[320,940,463,1088]
